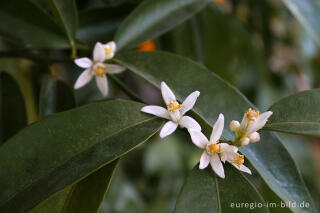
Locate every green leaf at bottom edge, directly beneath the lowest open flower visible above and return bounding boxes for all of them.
[175,164,269,213]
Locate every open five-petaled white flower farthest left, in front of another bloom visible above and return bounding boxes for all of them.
[74,42,125,96]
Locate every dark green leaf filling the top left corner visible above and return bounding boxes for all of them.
[0,0,69,48]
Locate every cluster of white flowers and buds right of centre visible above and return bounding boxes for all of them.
[141,82,272,178]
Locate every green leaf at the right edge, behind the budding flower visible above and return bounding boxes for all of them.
[264,89,320,136]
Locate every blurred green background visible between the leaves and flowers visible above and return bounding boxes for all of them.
[0,0,320,213]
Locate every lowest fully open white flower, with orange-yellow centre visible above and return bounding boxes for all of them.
[189,114,230,178]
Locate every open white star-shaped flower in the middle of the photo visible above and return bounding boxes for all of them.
[141,82,201,138]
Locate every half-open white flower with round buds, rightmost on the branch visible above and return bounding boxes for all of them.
[230,108,272,146]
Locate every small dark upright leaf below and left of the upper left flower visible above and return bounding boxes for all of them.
[39,78,75,118]
